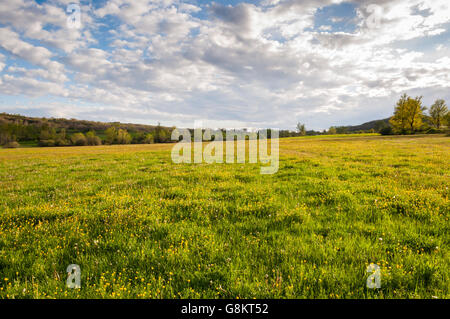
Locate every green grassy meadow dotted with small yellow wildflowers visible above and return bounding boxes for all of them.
[0,136,450,298]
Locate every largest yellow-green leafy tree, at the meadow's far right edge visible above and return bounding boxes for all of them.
[389,94,426,134]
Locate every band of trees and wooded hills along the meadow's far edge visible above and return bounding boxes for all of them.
[0,94,450,148]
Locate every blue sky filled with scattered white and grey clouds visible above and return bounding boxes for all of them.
[0,0,450,130]
